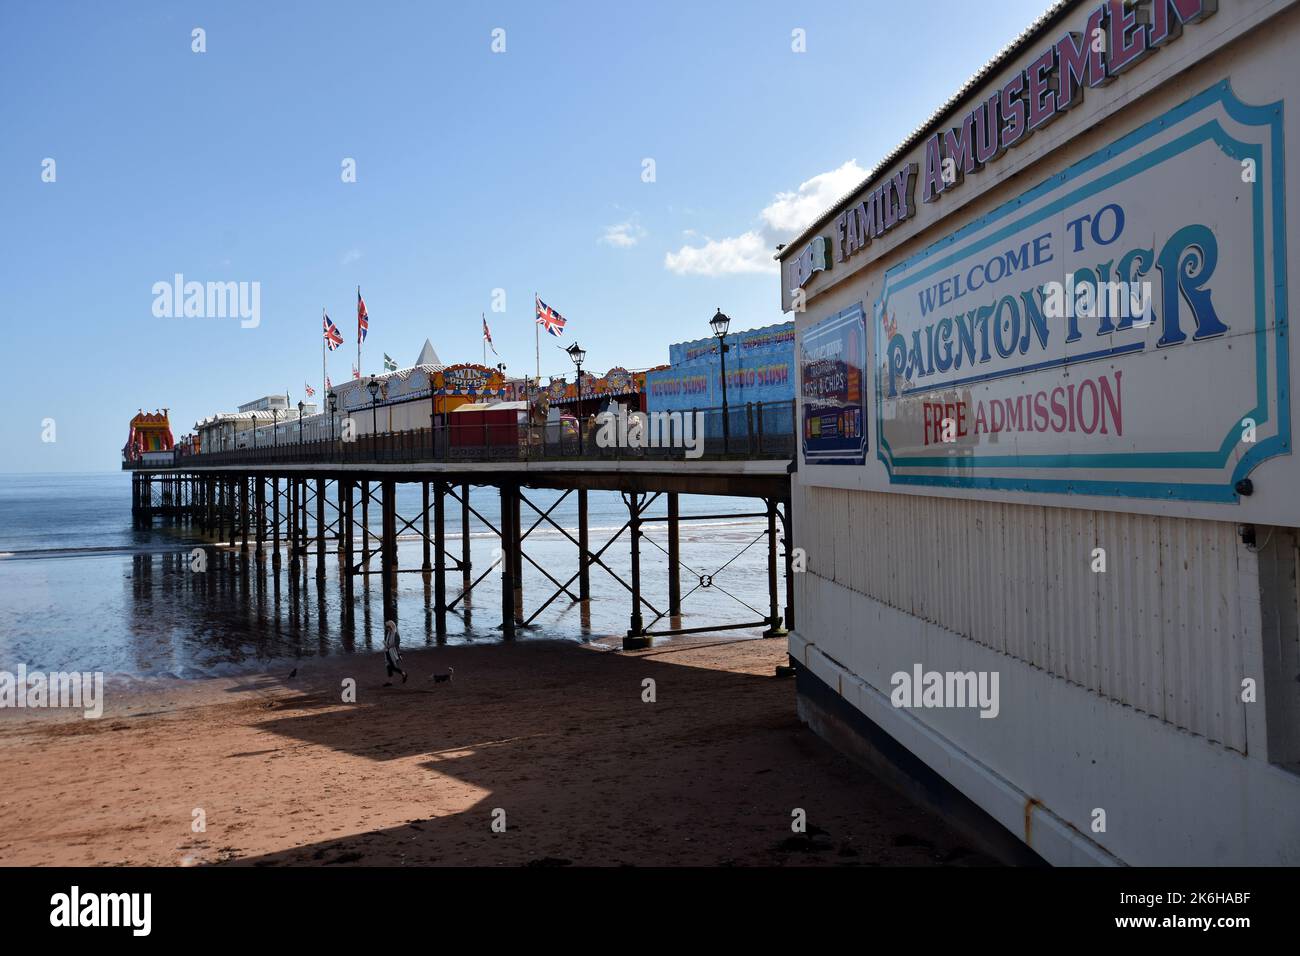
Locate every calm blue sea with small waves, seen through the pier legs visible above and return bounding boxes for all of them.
[0,472,785,679]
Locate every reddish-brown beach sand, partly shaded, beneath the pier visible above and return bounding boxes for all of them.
[0,637,992,866]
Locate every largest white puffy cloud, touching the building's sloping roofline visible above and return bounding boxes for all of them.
[663,160,867,276]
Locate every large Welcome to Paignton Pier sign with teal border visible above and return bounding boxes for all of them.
[874,83,1290,501]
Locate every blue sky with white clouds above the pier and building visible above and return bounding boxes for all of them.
[0,0,1048,472]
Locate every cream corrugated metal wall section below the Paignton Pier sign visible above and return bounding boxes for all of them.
[796,486,1258,753]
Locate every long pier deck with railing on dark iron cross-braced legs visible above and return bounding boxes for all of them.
[122,402,796,649]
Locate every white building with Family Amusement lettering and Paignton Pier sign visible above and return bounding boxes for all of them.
[779,0,1300,865]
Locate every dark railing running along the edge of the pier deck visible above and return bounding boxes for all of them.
[134,402,798,470]
